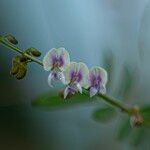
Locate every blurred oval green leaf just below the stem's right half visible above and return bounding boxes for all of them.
[93,107,115,122]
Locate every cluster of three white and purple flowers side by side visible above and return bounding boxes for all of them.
[43,48,107,99]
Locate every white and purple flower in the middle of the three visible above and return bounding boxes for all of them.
[64,62,89,99]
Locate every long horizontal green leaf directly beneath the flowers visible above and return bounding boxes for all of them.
[32,91,92,108]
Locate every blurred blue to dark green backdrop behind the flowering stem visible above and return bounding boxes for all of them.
[0,0,150,150]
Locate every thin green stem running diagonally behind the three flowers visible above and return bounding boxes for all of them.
[0,37,131,114]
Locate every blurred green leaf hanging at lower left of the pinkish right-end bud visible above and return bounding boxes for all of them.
[117,119,132,140]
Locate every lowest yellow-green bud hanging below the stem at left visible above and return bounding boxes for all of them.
[16,63,27,80]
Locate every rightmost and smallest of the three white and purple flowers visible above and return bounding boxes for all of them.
[89,67,107,97]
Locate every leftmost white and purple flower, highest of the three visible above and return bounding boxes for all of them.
[43,48,70,87]
